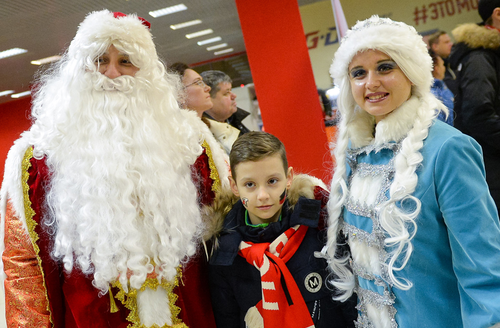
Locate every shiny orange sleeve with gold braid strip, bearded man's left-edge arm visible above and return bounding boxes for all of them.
[3,147,53,327]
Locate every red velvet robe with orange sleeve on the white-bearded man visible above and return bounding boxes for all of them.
[3,147,216,328]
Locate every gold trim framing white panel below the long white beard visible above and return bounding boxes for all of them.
[112,266,188,328]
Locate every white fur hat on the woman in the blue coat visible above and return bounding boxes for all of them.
[330,15,433,100]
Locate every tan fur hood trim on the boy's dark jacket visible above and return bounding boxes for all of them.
[201,174,328,241]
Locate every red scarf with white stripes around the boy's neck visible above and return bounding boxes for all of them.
[238,225,314,328]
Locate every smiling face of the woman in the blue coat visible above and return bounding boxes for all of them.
[349,50,411,123]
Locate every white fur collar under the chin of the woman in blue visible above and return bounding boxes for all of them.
[347,96,421,148]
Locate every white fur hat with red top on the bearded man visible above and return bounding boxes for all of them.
[68,10,158,69]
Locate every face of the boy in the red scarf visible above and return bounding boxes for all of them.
[229,154,293,224]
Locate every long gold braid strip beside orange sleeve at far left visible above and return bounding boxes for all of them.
[21,146,54,326]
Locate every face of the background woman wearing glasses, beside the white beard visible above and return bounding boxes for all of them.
[182,68,213,117]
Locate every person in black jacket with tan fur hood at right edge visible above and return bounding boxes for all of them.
[450,0,500,215]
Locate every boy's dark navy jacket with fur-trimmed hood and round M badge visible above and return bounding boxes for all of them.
[201,175,357,328]
